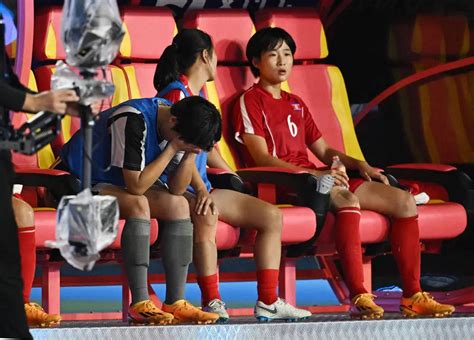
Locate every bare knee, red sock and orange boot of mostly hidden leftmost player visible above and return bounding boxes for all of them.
[12,194,61,327]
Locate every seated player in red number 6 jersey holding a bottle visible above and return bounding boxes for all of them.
[233,28,454,318]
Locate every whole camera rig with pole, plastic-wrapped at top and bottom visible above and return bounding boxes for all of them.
[44,0,124,270]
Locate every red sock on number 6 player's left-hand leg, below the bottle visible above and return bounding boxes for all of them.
[336,207,367,298]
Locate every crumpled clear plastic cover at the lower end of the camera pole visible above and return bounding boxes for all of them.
[46,189,119,270]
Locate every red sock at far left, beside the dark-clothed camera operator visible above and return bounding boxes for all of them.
[18,226,36,303]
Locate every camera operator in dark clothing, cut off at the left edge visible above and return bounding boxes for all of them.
[0,44,79,338]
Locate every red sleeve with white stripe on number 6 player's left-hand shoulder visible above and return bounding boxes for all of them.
[234,90,265,143]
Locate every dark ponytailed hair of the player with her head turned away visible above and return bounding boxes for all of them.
[153,28,214,92]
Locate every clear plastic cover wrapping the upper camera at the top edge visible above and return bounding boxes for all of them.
[61,0,125,69]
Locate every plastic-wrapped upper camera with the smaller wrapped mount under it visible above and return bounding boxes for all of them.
[51,0,125,106]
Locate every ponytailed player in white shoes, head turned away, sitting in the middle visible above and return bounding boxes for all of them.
[154,29,311,321]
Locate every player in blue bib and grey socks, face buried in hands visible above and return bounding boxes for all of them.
[61,96,221,324]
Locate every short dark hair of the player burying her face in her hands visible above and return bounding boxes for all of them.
[171,96,222,151]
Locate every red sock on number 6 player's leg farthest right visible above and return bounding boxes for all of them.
[391,216,421,297]
